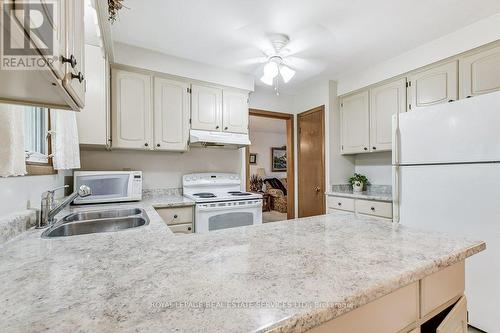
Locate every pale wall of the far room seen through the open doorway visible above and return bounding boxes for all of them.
[250,130,287,178]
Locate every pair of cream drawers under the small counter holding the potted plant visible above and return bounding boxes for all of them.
[327,195,392,219]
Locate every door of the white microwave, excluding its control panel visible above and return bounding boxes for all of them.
[74,173,133,204]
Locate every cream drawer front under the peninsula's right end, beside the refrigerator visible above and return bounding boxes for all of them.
[420,261,465,317]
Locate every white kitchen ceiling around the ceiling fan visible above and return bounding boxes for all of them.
[113,0,500,89]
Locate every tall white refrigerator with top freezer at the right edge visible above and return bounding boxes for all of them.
[393,93,500,333]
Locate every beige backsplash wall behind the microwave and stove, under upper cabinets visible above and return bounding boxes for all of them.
[81,148,242,189]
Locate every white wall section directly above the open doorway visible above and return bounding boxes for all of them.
[249,86,295,113]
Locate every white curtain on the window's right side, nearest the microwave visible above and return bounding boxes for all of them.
[50,110,80,170]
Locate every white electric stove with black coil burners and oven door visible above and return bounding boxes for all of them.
[182,173,262,233]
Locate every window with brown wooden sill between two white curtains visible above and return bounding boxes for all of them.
[24,106,54,175]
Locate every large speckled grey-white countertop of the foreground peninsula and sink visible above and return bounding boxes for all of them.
[0,203,485,332]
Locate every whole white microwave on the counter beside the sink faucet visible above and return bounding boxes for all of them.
[73,171,142,205]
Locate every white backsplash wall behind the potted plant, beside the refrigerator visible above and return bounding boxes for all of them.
[354,152,392,185]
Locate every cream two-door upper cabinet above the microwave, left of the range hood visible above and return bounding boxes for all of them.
[111,68,190,151]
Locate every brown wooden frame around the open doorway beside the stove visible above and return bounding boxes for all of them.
[245,109,295,219]
